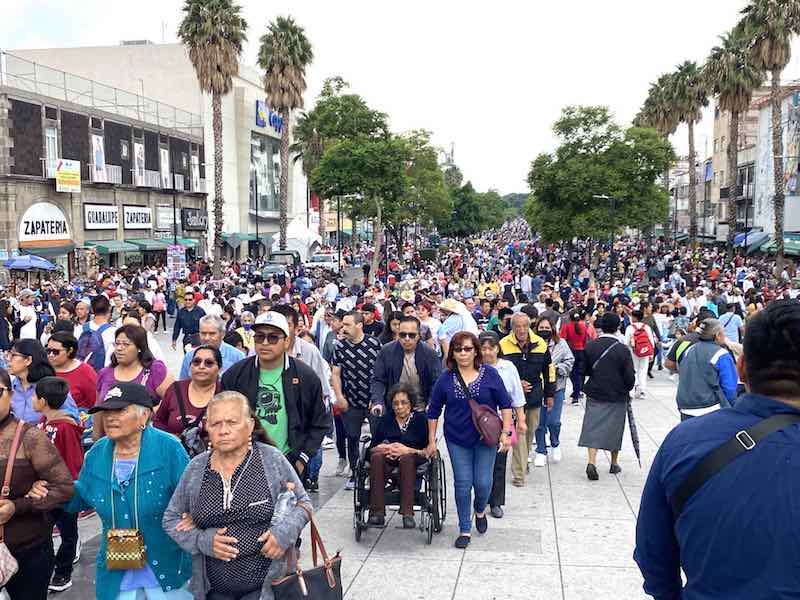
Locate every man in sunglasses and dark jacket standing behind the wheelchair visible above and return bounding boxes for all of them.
[370,315,442,410]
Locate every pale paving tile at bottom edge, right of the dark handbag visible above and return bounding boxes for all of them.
[344,551,462,600]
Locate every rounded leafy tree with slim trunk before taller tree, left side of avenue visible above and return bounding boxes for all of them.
[311,137,411,273]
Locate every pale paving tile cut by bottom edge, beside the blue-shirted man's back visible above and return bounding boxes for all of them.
[561,560,649,600]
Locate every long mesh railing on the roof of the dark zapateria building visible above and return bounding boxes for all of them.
[0,51,203,137]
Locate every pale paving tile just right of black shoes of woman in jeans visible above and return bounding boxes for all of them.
[460,515,558,565]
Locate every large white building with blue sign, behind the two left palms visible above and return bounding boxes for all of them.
[12,40,312,257]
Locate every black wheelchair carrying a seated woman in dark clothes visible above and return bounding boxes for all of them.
[353,435,447,544]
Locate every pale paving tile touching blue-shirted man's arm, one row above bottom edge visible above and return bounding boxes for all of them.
[556,516,636,567]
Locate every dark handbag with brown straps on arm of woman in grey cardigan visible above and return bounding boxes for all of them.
[272,504,342,600]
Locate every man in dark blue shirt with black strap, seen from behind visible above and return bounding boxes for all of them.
[634,300,800,600]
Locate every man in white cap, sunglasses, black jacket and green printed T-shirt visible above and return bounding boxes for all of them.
[222,311,329,479]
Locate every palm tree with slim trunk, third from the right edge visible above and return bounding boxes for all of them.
[672,60,708,246]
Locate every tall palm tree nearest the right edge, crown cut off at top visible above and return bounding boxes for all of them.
[742,0,800,273]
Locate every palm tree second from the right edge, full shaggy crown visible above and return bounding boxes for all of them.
[704,26,764,254]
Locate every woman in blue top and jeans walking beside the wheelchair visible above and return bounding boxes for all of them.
[427,331,511,548]
